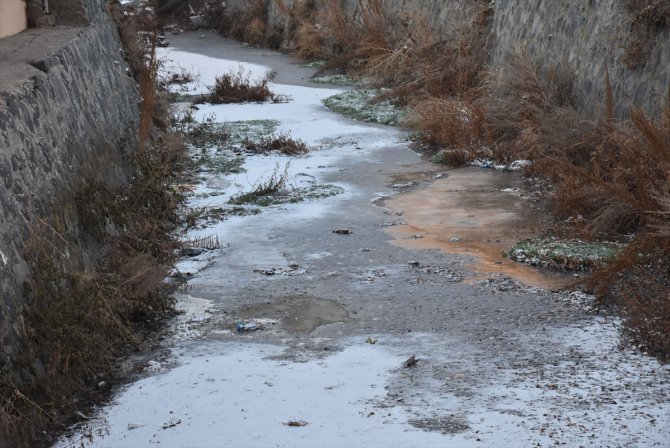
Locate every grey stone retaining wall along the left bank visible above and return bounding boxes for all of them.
[0,5,139,370]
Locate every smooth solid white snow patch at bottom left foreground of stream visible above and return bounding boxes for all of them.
[60,341,454,448]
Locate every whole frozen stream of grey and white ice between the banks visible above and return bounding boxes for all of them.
[57,33,670,447]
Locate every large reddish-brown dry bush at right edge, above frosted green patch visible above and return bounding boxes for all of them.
[542,109,670,234]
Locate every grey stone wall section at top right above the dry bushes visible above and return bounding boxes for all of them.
[491,0,670,116]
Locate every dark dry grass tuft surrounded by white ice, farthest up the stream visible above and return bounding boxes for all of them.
[195,67,288,104]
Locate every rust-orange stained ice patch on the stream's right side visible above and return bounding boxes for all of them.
[387,167,568,289]
